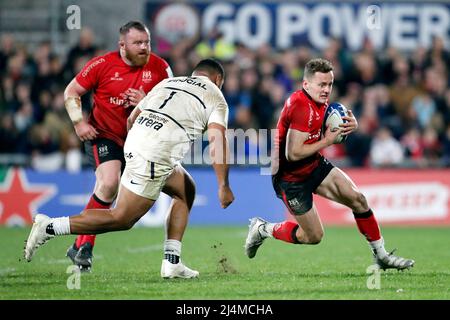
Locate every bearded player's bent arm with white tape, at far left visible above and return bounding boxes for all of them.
[64,78,98,141]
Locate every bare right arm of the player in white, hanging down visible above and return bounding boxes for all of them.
[208,123,234,209]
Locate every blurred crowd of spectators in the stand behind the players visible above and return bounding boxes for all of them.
[0,28,450,172]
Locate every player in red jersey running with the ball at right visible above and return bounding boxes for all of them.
[245,59,414,270]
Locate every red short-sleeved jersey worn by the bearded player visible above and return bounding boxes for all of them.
[76,51,172,147]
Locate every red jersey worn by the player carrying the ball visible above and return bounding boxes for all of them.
[272,90,326,182]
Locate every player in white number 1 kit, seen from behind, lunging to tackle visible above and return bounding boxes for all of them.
[24,59,234,278]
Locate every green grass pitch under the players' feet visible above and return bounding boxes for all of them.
[0,227,450,300]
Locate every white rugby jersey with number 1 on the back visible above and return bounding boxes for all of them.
[124,76,228,166]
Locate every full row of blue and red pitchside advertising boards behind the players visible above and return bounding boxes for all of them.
[0,166,450,227]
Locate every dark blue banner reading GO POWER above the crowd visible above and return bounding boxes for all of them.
[145,0,450,50]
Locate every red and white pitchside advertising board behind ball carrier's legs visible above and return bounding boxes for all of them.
[314,169,450,225]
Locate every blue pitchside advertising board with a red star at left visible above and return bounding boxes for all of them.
[0,168,285,226]
